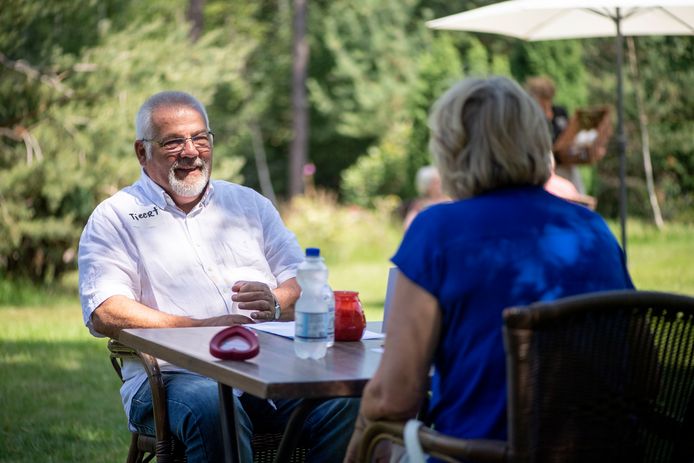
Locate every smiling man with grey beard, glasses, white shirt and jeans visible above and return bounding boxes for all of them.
[78,92,358,462]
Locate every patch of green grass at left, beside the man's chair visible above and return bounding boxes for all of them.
[0,304,129,463]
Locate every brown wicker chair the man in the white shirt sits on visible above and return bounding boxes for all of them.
[108,339,308,463]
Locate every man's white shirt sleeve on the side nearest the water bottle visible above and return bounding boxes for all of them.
[256,195,304,285]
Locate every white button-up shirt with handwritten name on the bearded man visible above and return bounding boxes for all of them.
[78,171,303,424]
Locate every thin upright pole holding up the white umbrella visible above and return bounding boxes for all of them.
[612,8,627,259]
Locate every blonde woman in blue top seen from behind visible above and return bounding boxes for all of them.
[346,77,633,461]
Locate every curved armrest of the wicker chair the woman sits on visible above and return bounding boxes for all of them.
[359,421,509,463]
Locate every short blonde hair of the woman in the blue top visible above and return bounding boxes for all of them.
[429,77,552,199]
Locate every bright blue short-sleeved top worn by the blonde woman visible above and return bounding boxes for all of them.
[392,187,634,439]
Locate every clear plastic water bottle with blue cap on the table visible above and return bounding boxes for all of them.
[294,248,328,359]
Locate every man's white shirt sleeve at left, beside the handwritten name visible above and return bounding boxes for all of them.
[77,205,140,337]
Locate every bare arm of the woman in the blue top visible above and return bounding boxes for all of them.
[345,272,441,462]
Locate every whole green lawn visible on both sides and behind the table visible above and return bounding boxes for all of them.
[0,223,694,463]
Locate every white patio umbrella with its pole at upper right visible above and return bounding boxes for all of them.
[427,0,694,253]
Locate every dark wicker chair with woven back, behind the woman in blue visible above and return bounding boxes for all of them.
[360,291,694,463]
